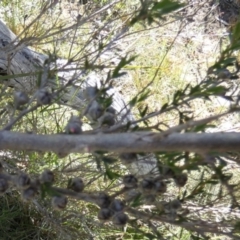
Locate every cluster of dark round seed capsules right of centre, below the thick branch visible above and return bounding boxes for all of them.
[119,153,188,219]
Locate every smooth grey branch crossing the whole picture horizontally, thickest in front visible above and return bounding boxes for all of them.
[0,131,240,154]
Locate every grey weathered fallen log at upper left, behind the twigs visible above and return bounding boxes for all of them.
[0,20,133,120]
